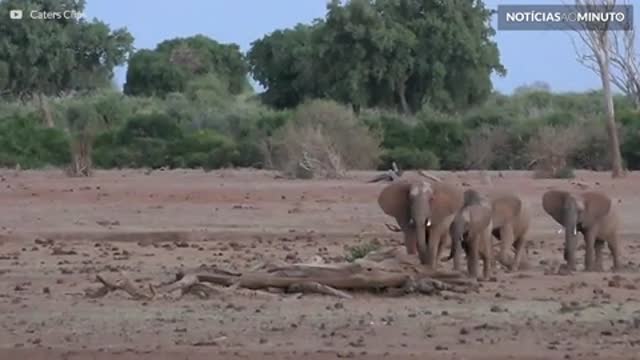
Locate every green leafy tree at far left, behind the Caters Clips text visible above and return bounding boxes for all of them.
[0,0,133,126]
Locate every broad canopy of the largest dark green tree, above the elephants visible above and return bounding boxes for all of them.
[247,0,506,112]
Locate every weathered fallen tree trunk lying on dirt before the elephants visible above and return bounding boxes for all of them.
[86,247,477,300]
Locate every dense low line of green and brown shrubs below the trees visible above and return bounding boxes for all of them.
[0,91,640,176]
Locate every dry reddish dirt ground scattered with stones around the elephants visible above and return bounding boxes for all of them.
[0,170,640,360]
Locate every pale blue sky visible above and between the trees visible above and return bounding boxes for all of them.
[85,0,639,93]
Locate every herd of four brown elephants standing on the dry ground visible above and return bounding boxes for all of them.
[378,176,620,279]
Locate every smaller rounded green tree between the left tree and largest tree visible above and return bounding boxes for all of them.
[124,35,250,96]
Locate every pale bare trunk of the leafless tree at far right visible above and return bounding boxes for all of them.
[597,33,624,178]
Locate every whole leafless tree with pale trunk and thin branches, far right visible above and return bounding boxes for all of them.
[575,0,624,178]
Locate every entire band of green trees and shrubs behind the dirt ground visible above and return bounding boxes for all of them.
[0,0,640,176]
